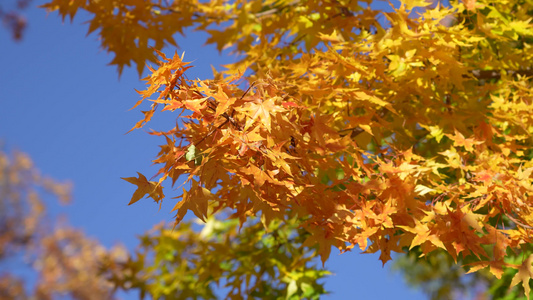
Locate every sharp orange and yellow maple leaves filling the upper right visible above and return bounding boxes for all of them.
[39,0,533,295]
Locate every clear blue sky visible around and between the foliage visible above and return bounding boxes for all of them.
[0,1,425,299]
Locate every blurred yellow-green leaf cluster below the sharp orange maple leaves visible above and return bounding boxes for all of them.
[103,217,329,299]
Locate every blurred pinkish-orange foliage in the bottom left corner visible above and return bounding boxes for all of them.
[0,151,125,299]
